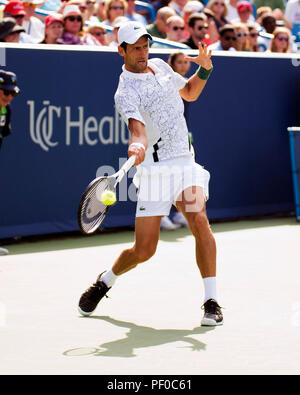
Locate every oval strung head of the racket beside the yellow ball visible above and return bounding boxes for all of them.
[79,178,110,233]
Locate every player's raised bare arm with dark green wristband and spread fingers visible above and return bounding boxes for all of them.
[179,42,213,101]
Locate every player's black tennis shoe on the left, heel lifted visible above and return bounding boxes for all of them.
[78,272,110,316]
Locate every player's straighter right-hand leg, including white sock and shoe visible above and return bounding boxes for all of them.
[176,186,223,325]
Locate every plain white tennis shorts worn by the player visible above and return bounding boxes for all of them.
[133,156,210,217]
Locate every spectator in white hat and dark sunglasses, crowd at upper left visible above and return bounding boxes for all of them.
[59,5,84,45]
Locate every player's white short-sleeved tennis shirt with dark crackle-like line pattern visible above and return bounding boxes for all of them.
[115,58,191,165]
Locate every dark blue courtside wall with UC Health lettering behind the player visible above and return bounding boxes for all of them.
[0,46,300,238]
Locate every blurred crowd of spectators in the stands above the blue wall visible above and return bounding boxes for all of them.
[0,0,300,52]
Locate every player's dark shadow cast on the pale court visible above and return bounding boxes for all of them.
[63,316,214,358]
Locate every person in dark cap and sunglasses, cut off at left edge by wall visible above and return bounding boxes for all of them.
[0,70,20,255]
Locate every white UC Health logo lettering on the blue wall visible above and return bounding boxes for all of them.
[27,100,129,152]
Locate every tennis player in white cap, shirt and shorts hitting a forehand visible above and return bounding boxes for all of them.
[79,22,223,326]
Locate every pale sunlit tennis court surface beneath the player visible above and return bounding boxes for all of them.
[0,218,300,375]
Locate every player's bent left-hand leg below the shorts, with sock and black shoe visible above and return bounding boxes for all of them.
[78,217,162,316]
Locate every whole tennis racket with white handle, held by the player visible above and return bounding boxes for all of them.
[77,155,136,234]
